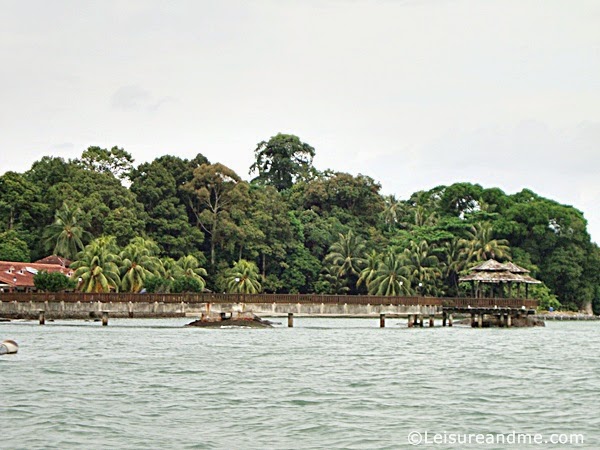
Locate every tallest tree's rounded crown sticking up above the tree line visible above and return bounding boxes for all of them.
[250,133,315,191]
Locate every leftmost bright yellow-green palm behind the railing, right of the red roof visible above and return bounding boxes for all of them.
[71,236,121,292]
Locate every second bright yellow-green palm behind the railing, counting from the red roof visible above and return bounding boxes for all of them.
[120,237,161,292]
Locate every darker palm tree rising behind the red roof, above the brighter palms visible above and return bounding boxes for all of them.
[44,202,89,259]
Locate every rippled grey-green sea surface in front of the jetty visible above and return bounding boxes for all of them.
[0,318,600,449]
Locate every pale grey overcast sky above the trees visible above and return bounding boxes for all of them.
[0,0,600,242]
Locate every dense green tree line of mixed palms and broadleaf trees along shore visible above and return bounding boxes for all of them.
[0,134,600,312]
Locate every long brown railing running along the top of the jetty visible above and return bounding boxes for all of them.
[0,292,538,309]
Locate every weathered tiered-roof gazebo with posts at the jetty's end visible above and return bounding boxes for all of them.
[458,259,541,298]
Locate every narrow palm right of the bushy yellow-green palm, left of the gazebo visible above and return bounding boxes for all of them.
[402,240,441,295]
